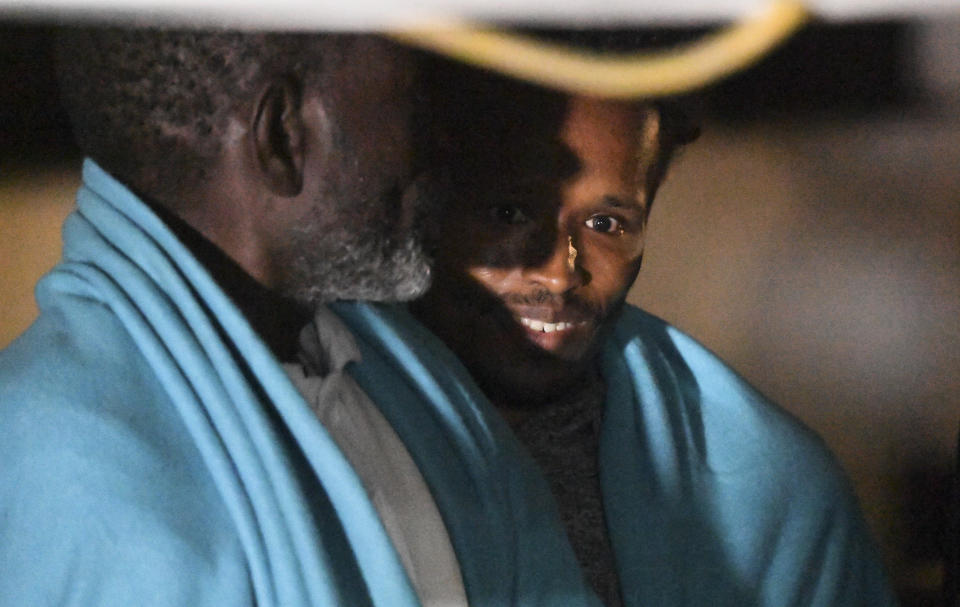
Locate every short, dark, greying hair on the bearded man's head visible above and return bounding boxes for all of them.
[56,27,334,201]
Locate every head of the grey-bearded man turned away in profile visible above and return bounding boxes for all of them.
[59,29,429,302]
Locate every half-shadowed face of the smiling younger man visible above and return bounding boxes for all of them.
[416,91,659,406]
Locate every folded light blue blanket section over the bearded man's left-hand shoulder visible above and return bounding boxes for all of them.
[0,161,417,607]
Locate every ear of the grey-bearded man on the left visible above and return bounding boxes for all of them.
[253,76,304,197]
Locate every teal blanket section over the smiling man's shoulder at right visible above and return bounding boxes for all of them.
[600,308,897,607]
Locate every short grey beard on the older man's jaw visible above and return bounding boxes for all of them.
[283,214,432,306]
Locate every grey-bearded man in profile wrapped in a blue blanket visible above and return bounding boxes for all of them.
[0,30,660,607]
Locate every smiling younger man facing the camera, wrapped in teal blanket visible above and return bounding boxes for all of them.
[404,60,895,607]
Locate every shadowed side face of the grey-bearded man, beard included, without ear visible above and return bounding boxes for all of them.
[276,36,430,303]
